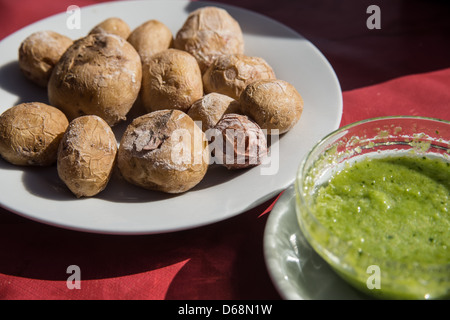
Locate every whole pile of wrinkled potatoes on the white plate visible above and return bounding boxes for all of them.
[0,7,303,197]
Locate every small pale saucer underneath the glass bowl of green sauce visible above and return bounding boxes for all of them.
[264,185,369,300]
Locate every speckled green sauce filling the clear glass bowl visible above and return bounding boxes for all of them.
[313,156,450,298]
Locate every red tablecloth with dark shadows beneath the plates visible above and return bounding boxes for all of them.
[0,0,450,300]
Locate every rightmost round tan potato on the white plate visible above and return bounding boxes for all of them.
[239,79,303,134]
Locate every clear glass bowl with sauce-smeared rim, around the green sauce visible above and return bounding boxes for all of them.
[295,116,450,299]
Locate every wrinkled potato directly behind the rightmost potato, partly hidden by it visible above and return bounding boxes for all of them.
[203,54,276,100]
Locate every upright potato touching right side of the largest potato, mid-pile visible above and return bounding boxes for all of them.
[141,48,203,112]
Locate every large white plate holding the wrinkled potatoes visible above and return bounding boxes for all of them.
[0,0,342,234]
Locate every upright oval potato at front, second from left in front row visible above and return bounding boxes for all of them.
[57,115,117,198]
